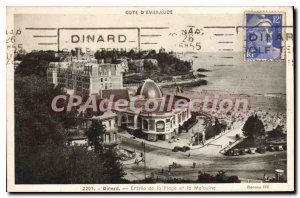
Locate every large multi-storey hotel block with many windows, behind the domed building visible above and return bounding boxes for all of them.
[47,49,127,95]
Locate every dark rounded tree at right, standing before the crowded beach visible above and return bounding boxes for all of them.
[242,115,265,139]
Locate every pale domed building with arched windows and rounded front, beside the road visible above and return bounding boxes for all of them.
[114,79,191,141]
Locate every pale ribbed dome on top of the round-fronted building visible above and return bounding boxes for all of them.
[136,79,163,99]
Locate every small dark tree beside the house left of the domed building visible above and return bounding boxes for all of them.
[85,120,105,152]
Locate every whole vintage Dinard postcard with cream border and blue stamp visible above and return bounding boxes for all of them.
[6,7,295,192]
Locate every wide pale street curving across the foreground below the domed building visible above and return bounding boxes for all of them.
[121,128,287,180]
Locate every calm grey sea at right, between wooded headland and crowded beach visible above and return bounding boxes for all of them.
[163,52,286,113]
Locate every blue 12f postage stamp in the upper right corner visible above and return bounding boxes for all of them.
[245,13,284,60]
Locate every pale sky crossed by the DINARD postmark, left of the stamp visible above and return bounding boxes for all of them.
[14,11,244,52]
